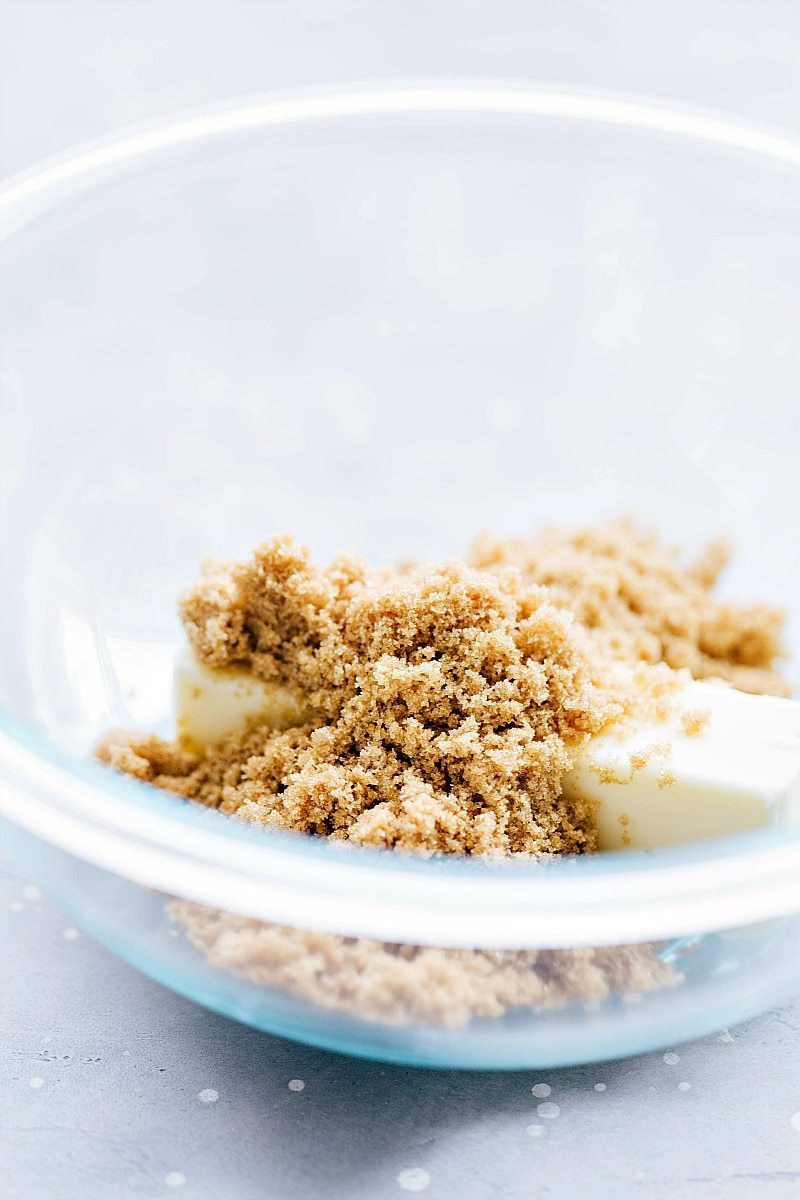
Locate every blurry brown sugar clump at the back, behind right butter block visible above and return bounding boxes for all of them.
[471,521,788,696]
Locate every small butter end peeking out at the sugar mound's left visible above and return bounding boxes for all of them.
[173,649,307,750]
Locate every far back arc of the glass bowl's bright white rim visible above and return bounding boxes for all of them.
[0,78,800,225]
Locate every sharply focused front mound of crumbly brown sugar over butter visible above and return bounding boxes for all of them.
[100,538,624,854]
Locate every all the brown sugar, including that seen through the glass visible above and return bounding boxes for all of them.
[98,522,787,1025]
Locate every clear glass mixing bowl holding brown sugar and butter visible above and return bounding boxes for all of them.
[0,84,800,1067]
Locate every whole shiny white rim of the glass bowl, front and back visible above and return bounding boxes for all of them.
[0,80,800,948]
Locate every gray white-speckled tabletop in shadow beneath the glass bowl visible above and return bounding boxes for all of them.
[0,875,800,1200]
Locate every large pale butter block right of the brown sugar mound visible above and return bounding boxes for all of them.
[564,682,800,850]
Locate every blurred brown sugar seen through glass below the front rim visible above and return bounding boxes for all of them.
[168,900,681,1027]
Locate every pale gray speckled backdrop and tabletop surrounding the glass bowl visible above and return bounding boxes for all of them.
[0,0,800,1200]
